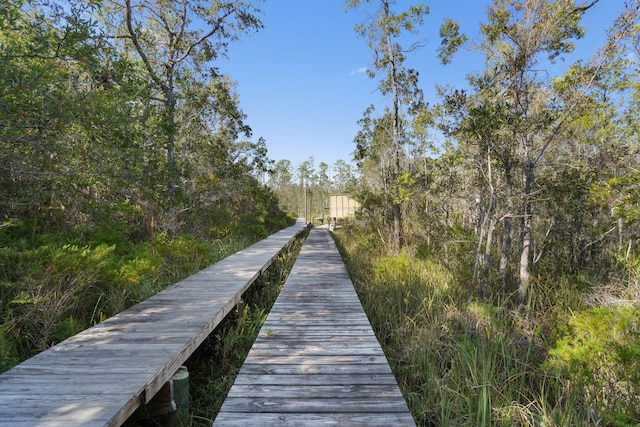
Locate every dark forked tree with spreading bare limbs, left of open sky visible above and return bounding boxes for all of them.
[103,0,262,202]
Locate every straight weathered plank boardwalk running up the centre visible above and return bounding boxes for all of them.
[214,229,415,427]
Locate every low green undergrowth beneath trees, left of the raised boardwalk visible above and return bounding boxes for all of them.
[0,217,296,372]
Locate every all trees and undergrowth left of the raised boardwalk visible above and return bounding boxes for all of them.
[0,0,291,369]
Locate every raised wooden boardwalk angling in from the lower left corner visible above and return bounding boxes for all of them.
[0,221,305,427]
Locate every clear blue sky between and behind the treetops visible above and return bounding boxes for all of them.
[215,0,624,172]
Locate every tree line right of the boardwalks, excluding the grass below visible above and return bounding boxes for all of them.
[346,0,640,307]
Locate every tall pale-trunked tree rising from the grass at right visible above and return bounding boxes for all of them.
[450,0,608,304]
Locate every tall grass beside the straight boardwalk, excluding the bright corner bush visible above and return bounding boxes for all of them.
[336,229,593,426]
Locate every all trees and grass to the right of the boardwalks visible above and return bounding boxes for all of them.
[335,0,640,426]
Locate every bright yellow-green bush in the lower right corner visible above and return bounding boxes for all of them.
[548,307,640,426]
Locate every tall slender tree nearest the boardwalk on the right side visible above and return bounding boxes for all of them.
[346,0,429,255]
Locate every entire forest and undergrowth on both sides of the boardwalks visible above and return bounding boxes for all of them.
[0,0,640,426]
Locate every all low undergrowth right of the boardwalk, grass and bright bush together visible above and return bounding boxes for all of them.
[336,227,640,426]
